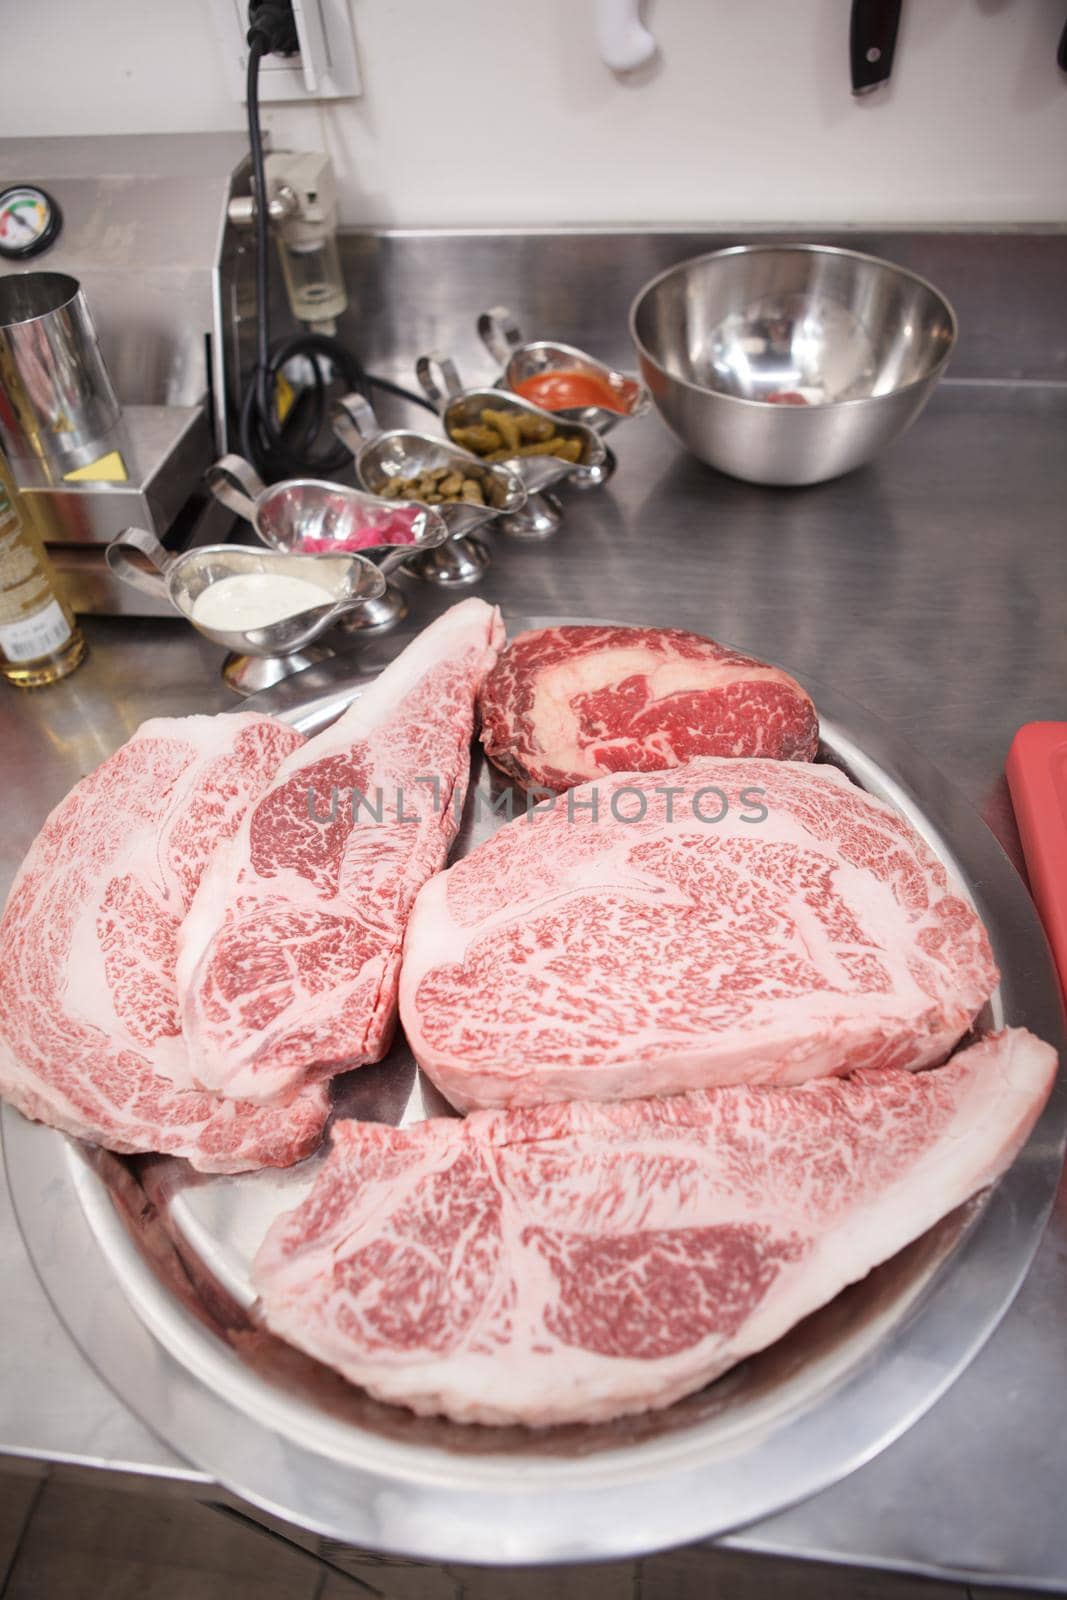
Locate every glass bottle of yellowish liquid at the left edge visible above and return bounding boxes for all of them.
[0,456,85,690]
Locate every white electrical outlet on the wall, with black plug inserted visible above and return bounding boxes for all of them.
[211,0,363,101]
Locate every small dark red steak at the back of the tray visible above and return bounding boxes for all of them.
[480,624,819,792]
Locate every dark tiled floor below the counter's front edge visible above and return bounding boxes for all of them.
[0,1462,1036,1600]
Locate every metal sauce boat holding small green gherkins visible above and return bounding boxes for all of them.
[414,352,609,539]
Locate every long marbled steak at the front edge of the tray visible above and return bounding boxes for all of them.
[253,1029,1056,1426]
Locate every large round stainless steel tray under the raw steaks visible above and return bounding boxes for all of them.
[2,618,1067,1563]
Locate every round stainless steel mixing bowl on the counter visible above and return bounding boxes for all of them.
[630,245,957,483]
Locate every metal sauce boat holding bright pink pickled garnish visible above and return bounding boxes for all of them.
[205,454,450,632]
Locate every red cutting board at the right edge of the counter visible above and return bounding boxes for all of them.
[1005,722,1067,997]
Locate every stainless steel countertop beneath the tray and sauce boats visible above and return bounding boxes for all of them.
[0,381,1067,1589]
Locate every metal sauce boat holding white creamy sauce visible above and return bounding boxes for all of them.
[106,528,386,694]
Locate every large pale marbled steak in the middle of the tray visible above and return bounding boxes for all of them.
[400,758,997,1110]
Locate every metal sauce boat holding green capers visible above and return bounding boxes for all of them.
[330,394,526,587]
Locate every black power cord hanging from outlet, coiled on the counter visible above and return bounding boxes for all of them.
[240,0,437,483]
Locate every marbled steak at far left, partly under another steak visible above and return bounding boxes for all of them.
[0,714,328,1173]
